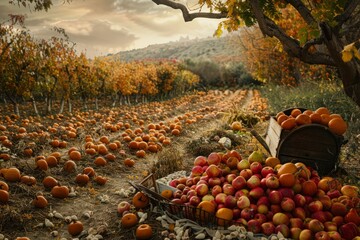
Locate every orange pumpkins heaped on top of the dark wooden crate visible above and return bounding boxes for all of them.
[276,107,348,135]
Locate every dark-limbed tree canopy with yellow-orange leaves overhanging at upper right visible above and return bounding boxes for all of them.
[152,0,360,106]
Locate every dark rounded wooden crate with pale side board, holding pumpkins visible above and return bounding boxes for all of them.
[265,117,344,175]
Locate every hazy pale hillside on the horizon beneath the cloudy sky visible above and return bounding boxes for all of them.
[111,37,240,62]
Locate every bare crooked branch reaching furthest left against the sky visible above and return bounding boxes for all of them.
[152,0,227,22]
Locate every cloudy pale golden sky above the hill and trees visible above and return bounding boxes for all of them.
[0,0,225,58]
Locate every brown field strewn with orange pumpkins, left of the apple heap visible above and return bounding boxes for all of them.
[0,90,266,239]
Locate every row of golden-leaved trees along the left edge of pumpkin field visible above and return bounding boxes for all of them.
[0,16,199,114]
